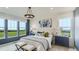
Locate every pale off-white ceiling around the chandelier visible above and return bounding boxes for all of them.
[0,7,75,17]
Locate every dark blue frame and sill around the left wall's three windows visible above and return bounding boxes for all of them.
[0,18,30,44]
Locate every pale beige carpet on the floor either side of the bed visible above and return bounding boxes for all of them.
[0,41,76,51]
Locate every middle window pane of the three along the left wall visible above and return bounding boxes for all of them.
[8,20,17,37]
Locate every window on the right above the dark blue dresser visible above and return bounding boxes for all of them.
[59,18,71,37]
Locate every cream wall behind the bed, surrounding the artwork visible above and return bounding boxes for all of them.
[31,14,59,34]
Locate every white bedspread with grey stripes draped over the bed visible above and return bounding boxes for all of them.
[15,35,52,51]
